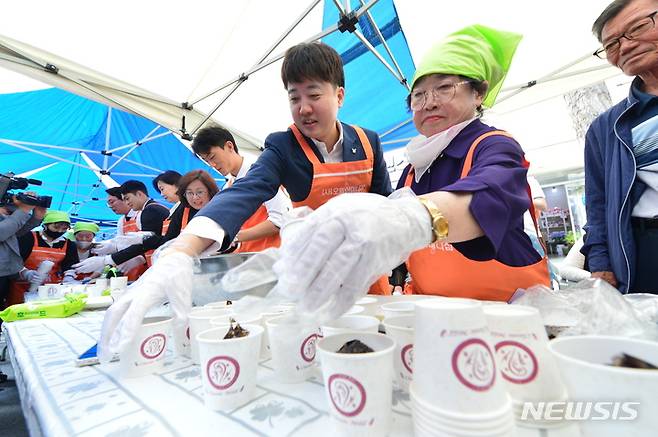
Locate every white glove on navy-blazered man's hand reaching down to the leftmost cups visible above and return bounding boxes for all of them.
[98,252,194,362]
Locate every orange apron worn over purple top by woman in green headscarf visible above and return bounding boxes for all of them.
[404,131,550,301]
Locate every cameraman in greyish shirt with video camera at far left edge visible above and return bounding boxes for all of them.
[0,193,46,308]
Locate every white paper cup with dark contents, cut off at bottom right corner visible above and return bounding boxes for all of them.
[548,335,658,437]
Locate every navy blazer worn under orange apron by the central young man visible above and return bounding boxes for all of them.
[197,123,393,245]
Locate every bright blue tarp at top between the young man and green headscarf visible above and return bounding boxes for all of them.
[322,0,418,150]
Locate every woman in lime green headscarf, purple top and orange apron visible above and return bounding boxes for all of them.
[264,25,549,318]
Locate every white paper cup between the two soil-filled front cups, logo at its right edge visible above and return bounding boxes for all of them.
[267,316,319,383]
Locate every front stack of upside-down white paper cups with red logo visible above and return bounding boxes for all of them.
[410,298,514,437]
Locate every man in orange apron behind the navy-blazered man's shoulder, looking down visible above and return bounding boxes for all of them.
[192,126,292,252]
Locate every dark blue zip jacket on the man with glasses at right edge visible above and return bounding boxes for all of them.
[581,79,643,293]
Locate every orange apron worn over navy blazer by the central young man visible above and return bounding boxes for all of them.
[290,124,391,294]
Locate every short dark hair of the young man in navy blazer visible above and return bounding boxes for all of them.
[281,42,345,89]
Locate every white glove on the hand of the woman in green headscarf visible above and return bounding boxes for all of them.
[273,190,432,322]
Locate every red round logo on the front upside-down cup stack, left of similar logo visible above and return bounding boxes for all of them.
[452,338,496,391]
